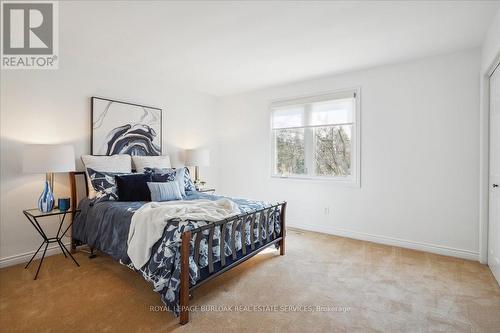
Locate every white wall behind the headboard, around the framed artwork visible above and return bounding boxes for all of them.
[0,7,217,266]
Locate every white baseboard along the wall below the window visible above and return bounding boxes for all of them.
[287,223,479,261]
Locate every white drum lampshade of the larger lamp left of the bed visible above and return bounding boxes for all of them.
[23,144,75,173]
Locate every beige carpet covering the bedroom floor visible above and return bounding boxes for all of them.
[0,230,500,332]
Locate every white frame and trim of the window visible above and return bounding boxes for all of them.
[269,87,361,187]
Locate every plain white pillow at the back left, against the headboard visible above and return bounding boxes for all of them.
[82,155,132,199]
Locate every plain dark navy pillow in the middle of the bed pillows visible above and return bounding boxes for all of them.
[115,173,152,201]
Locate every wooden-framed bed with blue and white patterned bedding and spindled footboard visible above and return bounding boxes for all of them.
[70,172,286,324]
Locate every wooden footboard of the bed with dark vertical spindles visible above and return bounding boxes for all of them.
[179,202,286,324]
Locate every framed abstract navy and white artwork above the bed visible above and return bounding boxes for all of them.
[90,97,162,156]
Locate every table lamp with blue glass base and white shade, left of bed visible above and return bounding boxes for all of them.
[23,144,75,213]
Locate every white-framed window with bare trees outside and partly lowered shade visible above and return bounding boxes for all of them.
[271,90,359,183]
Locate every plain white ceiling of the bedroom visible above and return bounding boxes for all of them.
[64,1,500,96]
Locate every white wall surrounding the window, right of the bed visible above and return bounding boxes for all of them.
[218,49,480,259]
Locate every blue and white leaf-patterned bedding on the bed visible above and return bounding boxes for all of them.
[73,192,280,315]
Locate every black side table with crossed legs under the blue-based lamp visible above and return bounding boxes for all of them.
[23,208,80,280]
